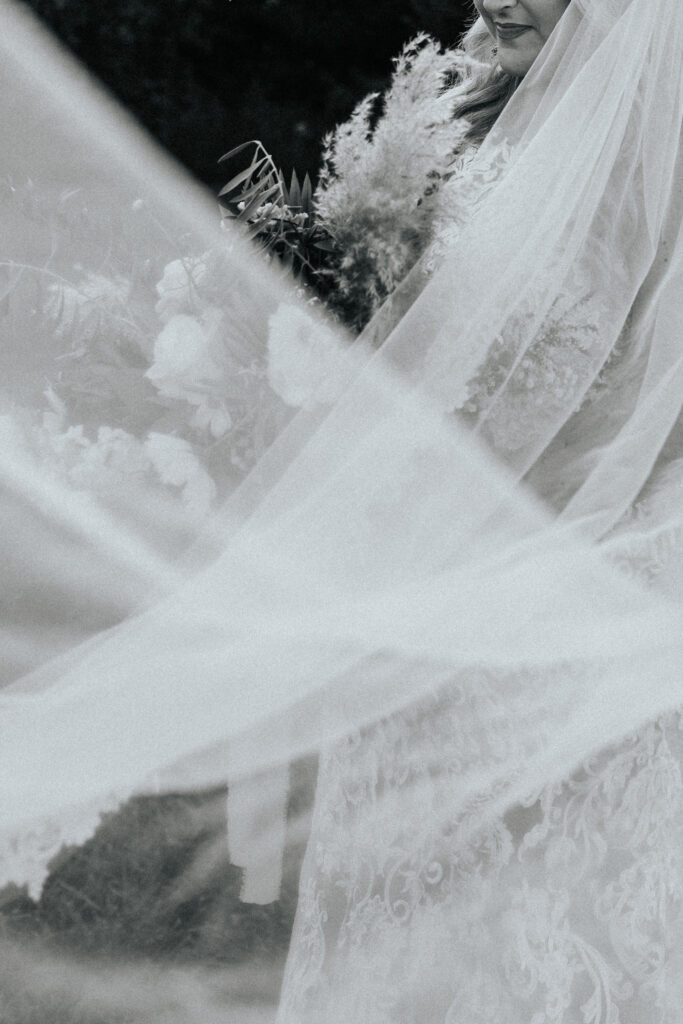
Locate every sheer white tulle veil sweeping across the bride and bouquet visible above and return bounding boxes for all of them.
[0,0,683,1019]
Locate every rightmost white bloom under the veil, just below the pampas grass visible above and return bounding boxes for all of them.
[267,303,354,409]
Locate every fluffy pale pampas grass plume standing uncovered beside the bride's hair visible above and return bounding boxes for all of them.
[315,35,467,330]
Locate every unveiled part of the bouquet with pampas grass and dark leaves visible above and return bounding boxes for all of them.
[220,35,463,331]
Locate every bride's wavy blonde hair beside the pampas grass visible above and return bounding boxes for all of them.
[454,17,521,145]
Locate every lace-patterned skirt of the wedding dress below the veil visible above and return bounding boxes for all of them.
[279,695,683,1024]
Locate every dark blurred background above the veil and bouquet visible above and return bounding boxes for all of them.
[20,0,471,188]
